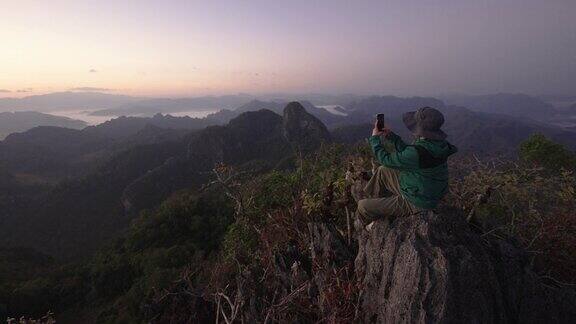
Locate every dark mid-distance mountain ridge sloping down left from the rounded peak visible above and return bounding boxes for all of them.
[0,102,330,259]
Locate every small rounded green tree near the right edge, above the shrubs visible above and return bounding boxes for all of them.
[520,133,576,170]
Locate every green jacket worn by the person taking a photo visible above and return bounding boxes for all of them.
[368,132,457,209]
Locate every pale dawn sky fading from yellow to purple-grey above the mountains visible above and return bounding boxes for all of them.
[0,0,576,97]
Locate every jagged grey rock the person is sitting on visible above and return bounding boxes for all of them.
[355,214,576,323]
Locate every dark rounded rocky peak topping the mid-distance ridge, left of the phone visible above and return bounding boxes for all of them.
[283,102,330,151]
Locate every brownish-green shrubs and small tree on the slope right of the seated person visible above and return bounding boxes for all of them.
[445,135,576,282]
